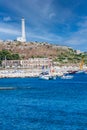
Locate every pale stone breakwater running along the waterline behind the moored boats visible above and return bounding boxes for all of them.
[0,66,87,78]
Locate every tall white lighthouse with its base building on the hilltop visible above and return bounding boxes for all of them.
[17,18,26,42]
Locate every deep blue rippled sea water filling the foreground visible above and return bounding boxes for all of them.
[0,73,87,130]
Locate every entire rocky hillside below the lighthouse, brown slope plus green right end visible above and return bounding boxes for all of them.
[0,41,87,64]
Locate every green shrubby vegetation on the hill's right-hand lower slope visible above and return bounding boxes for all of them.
[54,48,87,64]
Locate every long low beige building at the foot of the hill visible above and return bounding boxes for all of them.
[2,58,52,68]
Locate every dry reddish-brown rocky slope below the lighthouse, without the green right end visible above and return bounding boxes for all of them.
[0,42,68,59]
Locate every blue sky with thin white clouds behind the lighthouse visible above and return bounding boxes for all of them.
[0,0,87,51]
